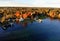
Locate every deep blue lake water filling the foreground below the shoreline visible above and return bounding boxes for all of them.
[0,18,60,41]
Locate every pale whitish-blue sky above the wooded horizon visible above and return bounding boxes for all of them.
[0,0,60,8]
